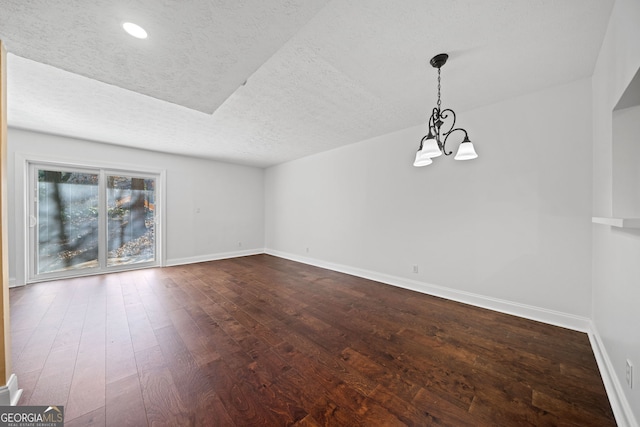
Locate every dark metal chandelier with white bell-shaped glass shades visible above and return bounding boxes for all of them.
[413,53,478,167]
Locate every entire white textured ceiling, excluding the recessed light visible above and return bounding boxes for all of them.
[0,0,613,167]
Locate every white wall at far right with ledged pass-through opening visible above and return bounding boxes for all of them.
[592,0,640,425]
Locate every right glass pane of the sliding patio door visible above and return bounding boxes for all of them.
[107,175,156,267]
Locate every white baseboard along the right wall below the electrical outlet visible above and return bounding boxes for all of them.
[589,323,638,427]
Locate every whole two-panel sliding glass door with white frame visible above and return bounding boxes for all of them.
[29,164,159,281]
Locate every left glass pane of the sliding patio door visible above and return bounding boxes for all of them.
[35,169,99,274]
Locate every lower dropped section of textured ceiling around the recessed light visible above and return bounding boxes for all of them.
[0,0,326,114]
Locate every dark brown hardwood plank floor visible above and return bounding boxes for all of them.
[10,255,615,427]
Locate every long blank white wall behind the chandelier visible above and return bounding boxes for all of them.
[265,79,592,329]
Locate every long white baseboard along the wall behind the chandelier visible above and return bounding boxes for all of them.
[264,248,591,333]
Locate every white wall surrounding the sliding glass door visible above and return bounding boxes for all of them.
[8,128,264,285]
